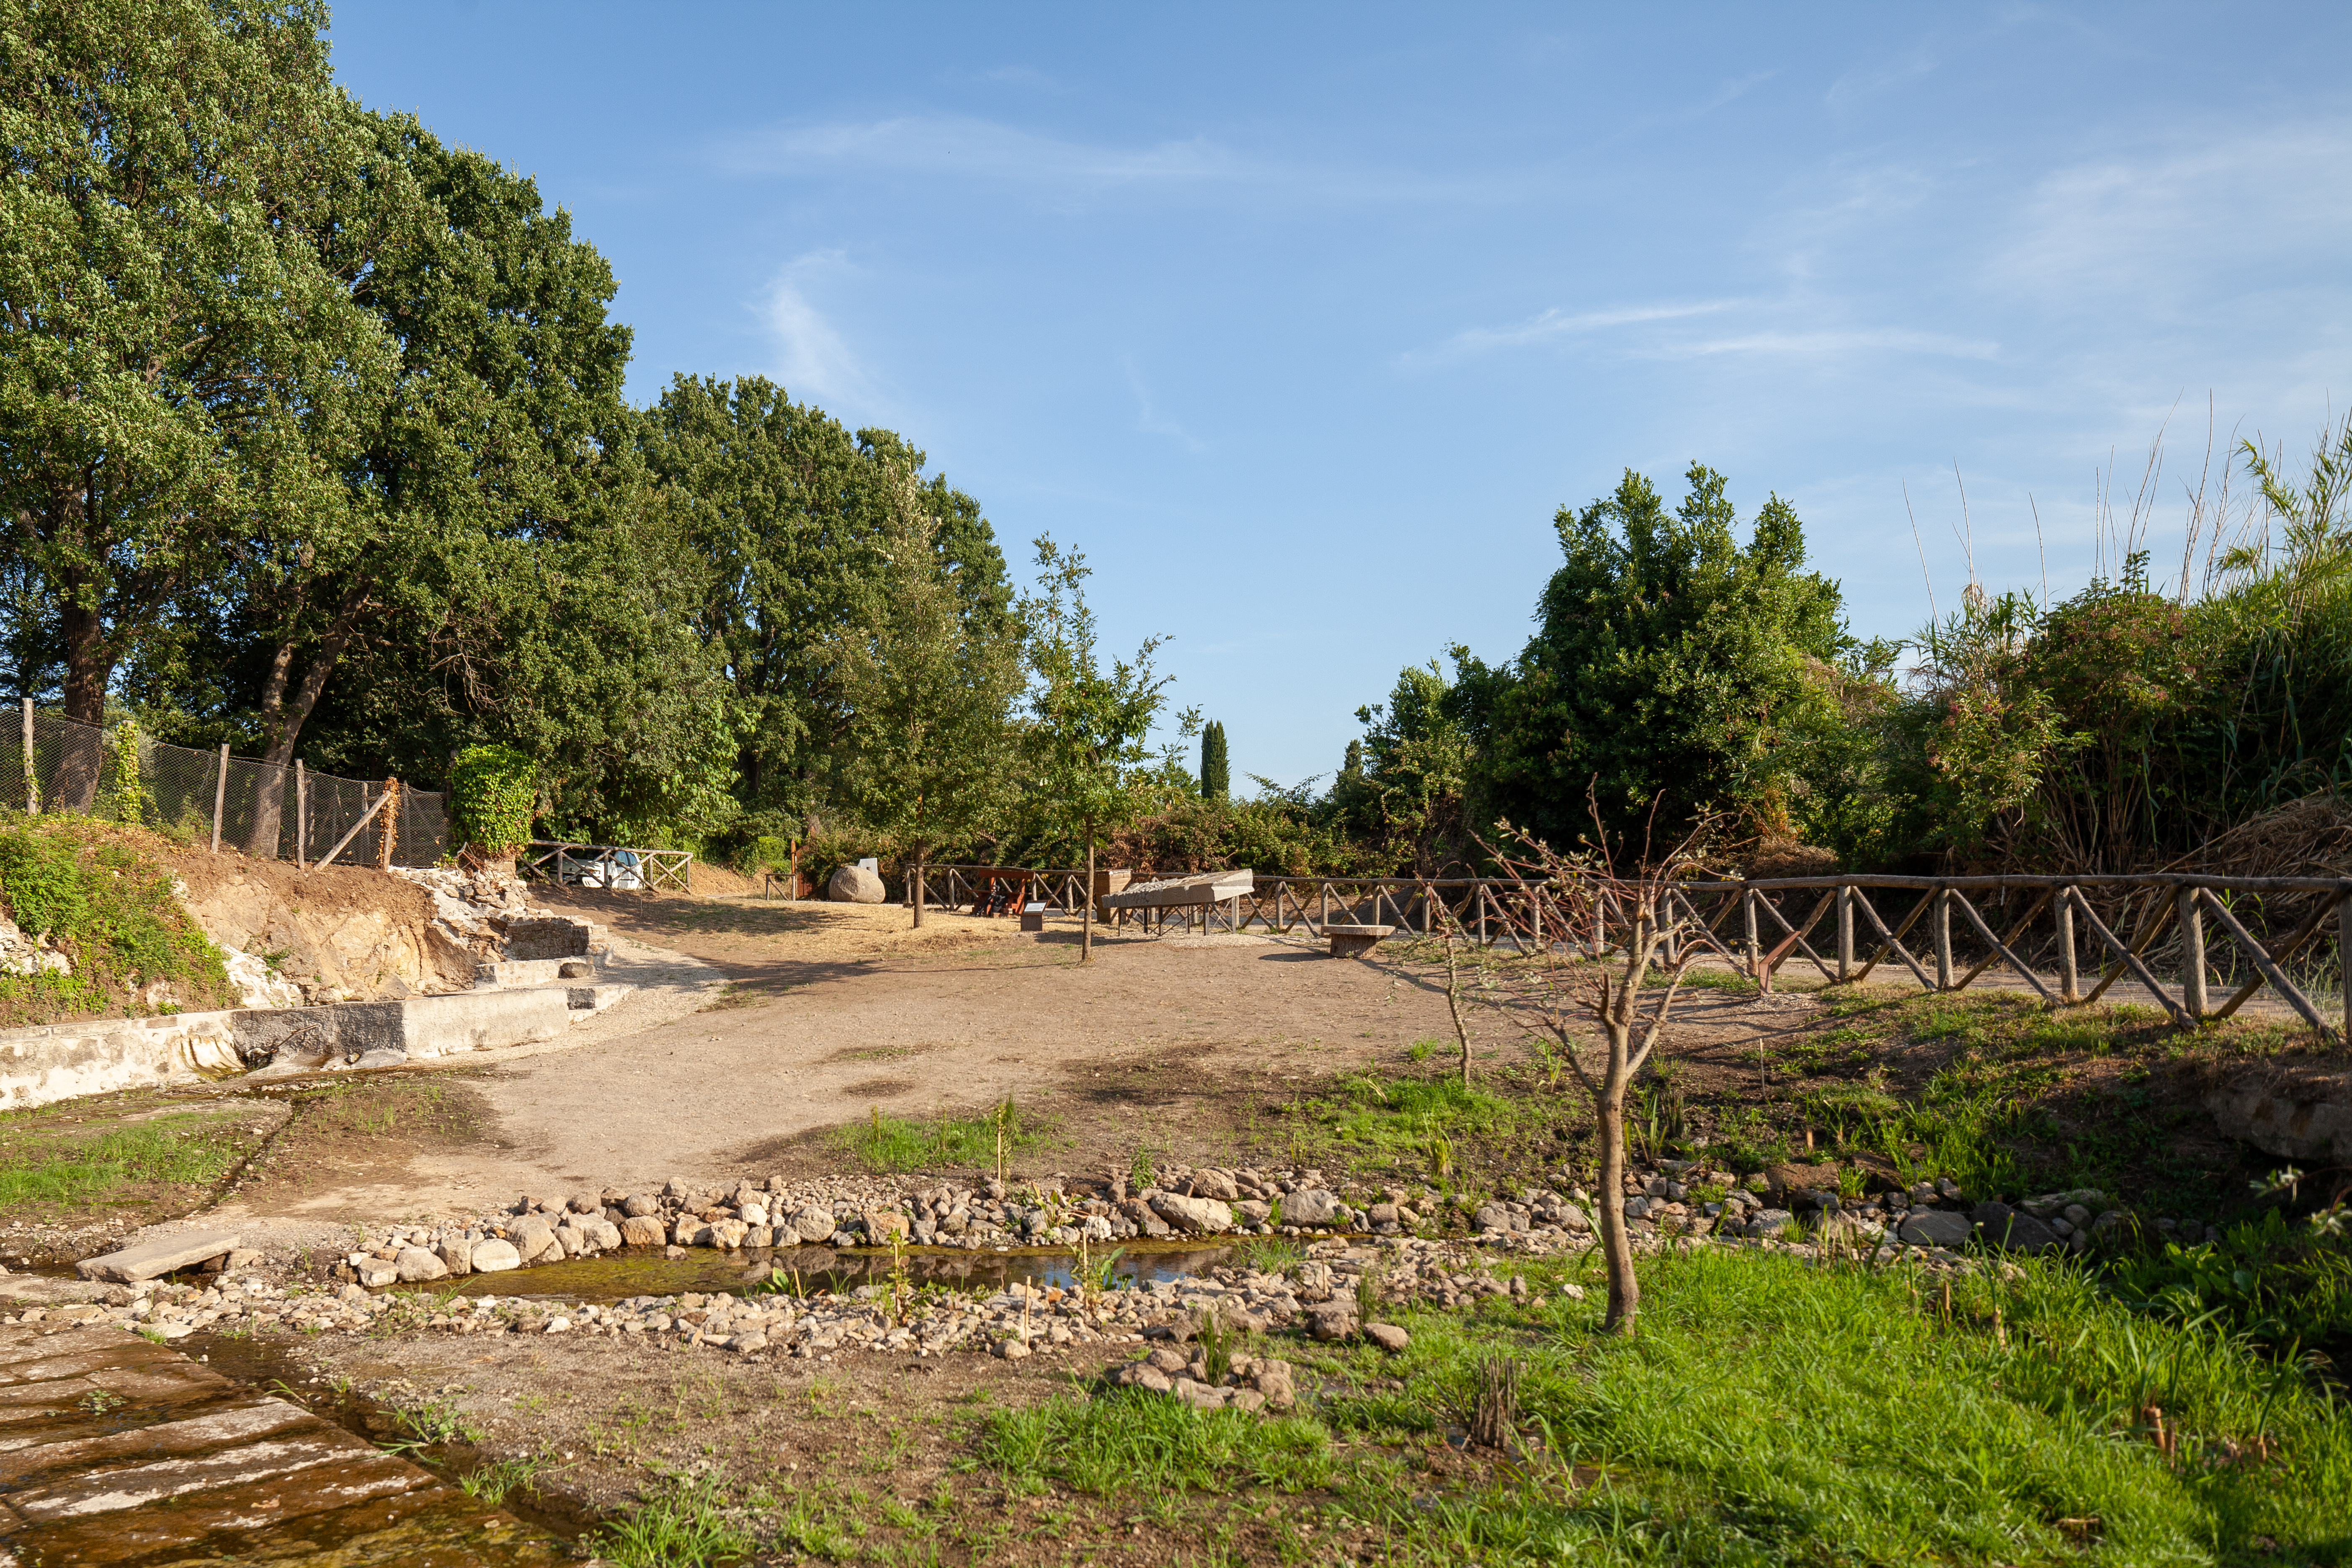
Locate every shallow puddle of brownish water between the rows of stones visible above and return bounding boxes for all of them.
[390,1241,1233,1302]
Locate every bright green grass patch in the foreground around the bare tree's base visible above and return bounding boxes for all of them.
[978,1253,2352,1565]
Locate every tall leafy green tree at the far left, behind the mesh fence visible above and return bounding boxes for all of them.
[0,0,400,799]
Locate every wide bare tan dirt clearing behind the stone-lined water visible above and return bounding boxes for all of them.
[197,896,1816,1220]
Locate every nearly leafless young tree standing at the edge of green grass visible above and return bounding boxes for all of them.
[1489,823,1715,1335]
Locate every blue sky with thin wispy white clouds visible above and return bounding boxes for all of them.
[332,0,2352,783]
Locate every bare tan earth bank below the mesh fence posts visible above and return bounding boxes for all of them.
[160,846,475,1001]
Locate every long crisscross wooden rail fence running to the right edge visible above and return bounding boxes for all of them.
[929,865,2352,1039]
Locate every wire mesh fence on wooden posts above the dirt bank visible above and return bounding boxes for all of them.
[0,708,449,865]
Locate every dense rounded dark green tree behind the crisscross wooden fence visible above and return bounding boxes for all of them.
[1454,465,1851,851]
